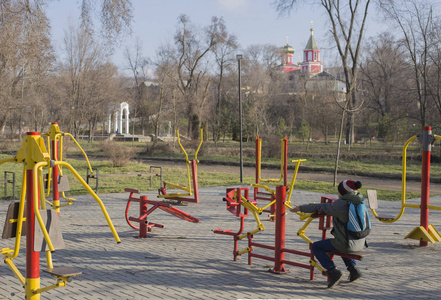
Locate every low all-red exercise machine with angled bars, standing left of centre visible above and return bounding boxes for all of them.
[124,188,200,238]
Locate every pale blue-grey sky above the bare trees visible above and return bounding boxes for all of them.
[44,0,382,70]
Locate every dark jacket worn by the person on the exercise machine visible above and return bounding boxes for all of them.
[300,191,366,253]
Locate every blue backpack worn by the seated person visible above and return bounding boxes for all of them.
[346,202,371,240]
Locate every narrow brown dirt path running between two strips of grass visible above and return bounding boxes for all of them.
[144,160,441,195]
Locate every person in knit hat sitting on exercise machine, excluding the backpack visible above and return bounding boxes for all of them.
[290,180,366,288]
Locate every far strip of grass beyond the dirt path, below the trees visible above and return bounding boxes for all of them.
[59,138,441,177]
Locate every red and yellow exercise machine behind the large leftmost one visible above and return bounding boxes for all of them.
[41,123,92,213]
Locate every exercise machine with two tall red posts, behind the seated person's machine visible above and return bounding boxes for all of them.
[251,136,288,221]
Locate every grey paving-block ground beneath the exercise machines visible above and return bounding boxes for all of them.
[0,187,441,300]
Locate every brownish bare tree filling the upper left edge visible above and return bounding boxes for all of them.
[0,1,54,134]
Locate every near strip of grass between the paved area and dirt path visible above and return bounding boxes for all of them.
[0,155,422,201]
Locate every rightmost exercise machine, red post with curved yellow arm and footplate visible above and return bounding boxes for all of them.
[368,127,441,246]
